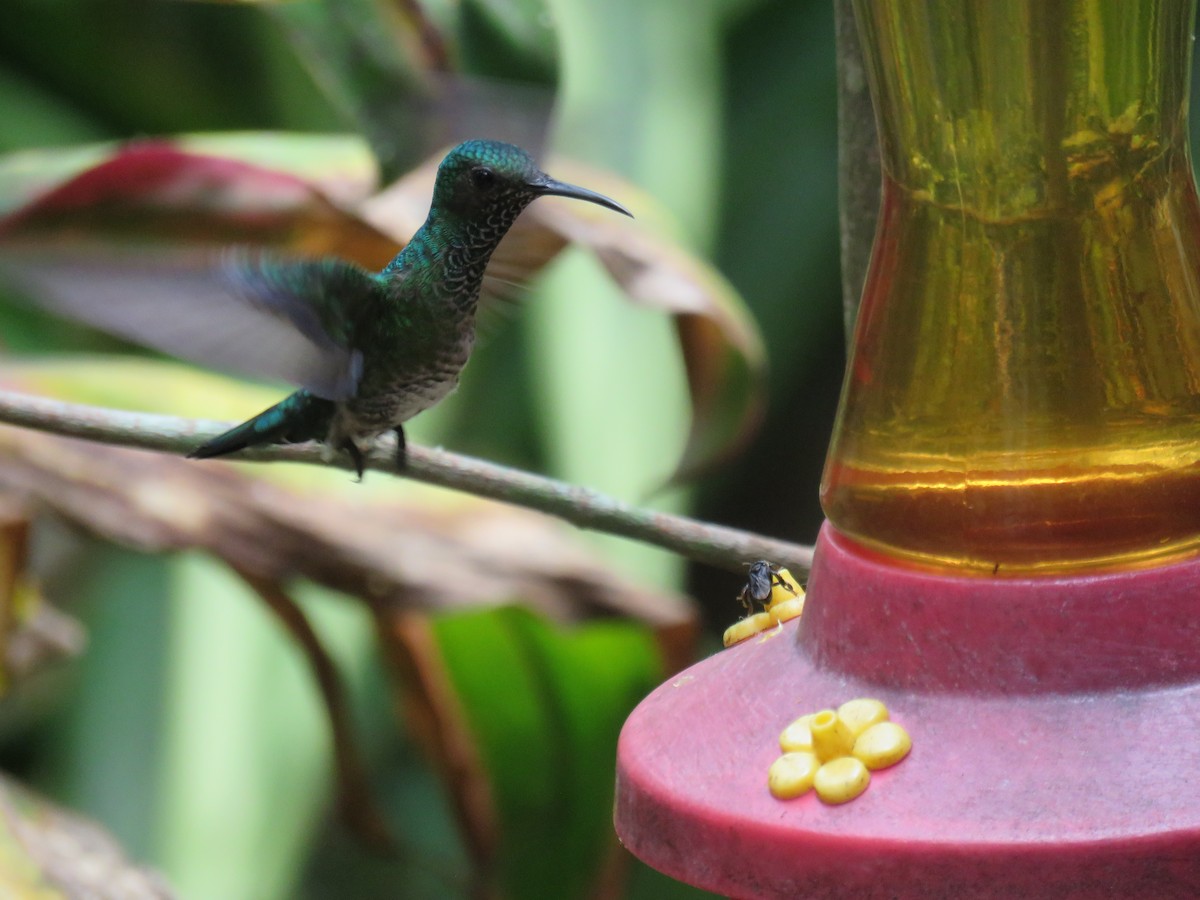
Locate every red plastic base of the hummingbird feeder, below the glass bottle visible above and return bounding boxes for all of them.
[616,526,1200,900]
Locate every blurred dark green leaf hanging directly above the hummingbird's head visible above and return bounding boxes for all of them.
[205,0,557,179]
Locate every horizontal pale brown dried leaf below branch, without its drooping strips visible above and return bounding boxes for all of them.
[0,427,694,632]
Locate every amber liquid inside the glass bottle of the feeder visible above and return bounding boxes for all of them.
[822,0,1200,575]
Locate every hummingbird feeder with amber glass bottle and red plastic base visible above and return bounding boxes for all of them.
[616,0,1200,900]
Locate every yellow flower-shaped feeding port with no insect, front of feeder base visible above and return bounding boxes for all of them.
[767,697,912,804]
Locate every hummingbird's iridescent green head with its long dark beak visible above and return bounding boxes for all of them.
[433,140,630,228]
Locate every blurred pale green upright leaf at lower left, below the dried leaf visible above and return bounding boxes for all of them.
[155,554,370,900]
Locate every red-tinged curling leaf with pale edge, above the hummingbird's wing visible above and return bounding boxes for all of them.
[0,136,398,269]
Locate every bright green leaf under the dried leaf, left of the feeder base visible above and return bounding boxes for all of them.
[408,607,662,899]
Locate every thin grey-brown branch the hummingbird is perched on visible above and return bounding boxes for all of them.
[0,391,812,574]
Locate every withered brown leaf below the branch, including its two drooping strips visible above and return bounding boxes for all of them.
[0,427,696,859]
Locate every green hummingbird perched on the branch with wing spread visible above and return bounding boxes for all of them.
[4,140,630,479]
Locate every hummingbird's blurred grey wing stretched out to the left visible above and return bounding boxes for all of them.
[0,246,379,401]
